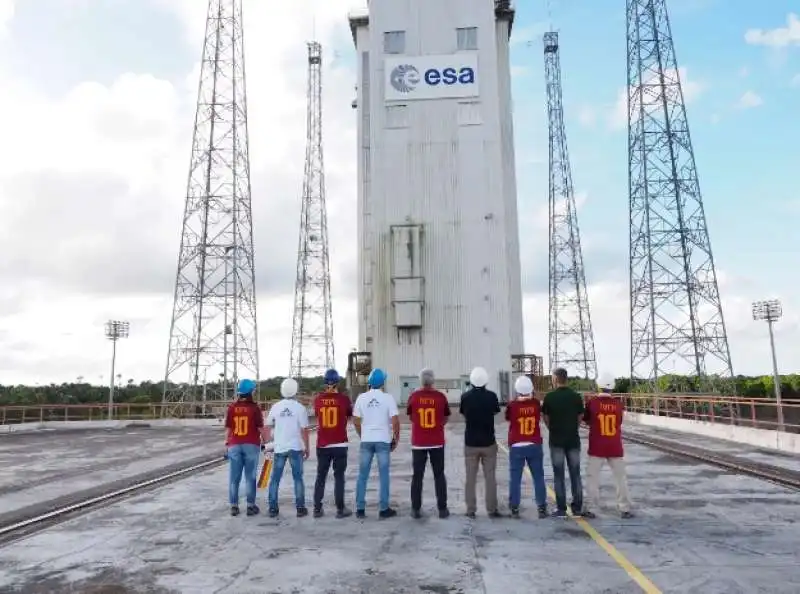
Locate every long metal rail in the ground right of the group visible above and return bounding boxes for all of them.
[625,432,800,490]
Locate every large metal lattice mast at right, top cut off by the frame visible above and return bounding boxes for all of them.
[627,0,733,390]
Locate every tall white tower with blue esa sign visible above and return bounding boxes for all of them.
[350,0,523,402]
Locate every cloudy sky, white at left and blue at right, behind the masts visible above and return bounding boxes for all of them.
[0,0,800,384]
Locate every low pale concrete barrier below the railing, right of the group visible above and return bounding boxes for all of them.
[625,412,800,454]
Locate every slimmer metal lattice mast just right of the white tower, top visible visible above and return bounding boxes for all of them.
[544,31,597,379]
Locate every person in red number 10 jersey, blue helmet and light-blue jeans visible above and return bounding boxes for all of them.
[225,379,266,516]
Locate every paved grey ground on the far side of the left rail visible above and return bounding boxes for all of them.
[0,420,224,514]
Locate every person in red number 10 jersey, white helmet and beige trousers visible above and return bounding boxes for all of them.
[584,376,633,518]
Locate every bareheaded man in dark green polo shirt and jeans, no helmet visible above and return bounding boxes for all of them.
[542,367,583,518]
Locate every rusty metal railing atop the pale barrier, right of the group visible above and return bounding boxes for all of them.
[615,394,800,433]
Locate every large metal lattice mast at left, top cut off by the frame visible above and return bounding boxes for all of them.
[164,0,259,407]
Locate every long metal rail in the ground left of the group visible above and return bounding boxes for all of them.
[0,456,225,546]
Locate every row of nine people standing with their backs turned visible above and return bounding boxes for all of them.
[225,367,632,518]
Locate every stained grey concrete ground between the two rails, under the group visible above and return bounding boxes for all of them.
[0,424,800,594]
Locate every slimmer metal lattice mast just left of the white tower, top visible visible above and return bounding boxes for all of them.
[290,41,334,381]
